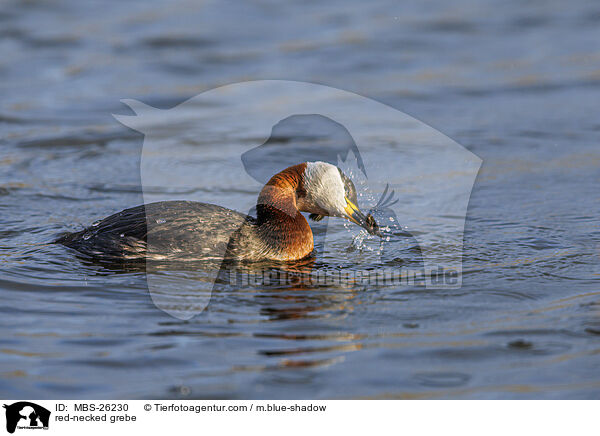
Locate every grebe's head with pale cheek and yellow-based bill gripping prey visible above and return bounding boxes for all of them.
[298,162,381,236]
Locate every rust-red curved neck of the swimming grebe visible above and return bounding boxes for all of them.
[256,163,314,260]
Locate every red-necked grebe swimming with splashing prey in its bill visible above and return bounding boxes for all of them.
[56,162,381,261]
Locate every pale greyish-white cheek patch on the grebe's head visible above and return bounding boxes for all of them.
[304,162,346,216]
